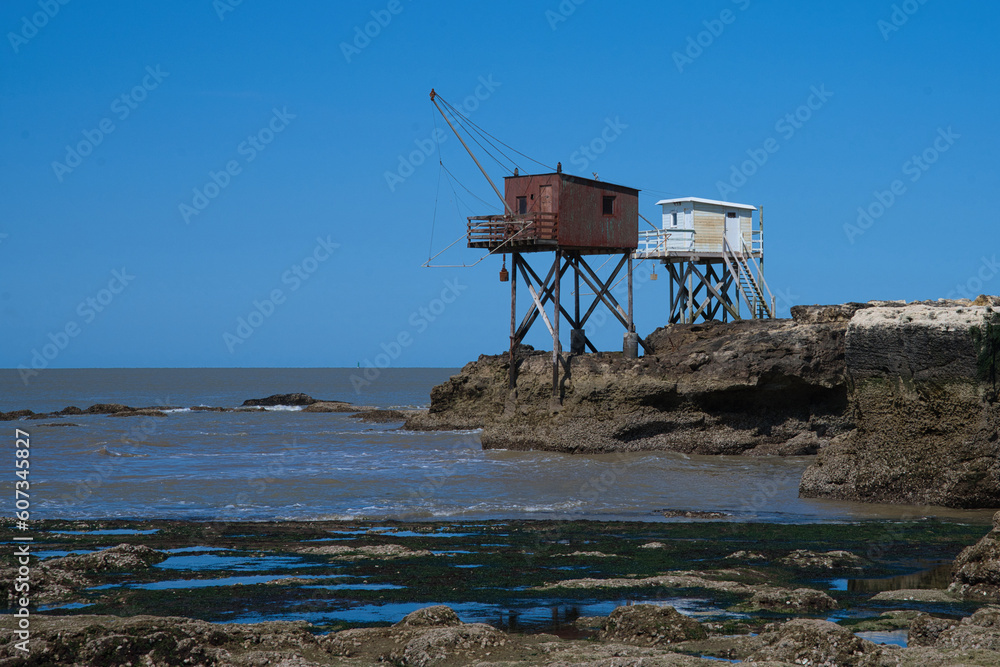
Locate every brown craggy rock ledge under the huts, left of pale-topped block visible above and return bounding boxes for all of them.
[406,305,861,454]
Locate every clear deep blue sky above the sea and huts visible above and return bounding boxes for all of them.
[0,0,1000,368]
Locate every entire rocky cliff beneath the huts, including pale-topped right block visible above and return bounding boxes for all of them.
[405,296,1000,508]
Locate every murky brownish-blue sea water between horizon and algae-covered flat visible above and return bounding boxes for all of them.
[0,369,990,522]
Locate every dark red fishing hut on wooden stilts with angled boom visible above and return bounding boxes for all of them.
[425,90,646,408]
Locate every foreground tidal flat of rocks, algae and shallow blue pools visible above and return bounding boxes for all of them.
[9,516,1000,667]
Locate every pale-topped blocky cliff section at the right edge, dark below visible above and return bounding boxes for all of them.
[800,303,1000,507]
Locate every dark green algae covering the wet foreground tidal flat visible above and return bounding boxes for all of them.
[3,520,988,630]
